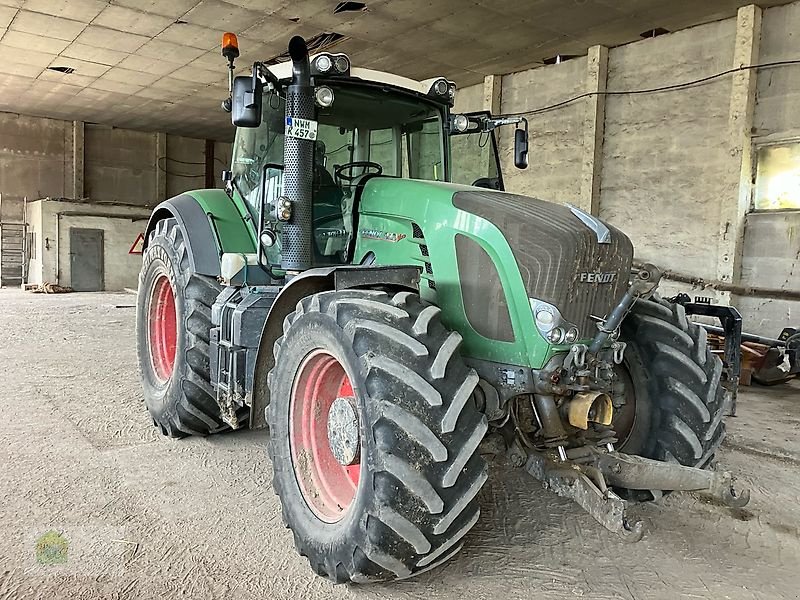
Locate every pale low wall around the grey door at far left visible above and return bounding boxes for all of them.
[28,200,149,290]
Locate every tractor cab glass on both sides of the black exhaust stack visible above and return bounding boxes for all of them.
[232,82,448,264]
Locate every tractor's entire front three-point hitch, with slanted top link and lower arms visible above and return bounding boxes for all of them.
[509,265,750,542]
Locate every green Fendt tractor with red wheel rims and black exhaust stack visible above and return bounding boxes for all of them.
[137,34,749,582]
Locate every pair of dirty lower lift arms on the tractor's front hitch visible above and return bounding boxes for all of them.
[524,447,750,542]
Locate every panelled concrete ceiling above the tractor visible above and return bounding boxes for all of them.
[0,0,788,139]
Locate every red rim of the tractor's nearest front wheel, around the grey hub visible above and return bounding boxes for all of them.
[289,350,361,523]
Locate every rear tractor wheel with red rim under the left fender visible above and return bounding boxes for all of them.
[136,218,241,437]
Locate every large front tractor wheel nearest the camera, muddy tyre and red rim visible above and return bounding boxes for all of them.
[267,290,487,583]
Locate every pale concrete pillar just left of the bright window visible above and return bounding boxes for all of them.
[717,4,762,296]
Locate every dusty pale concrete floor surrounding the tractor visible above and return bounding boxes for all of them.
[0,290,800,600]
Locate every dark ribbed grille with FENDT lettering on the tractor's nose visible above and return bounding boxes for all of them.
[453,191,633,337]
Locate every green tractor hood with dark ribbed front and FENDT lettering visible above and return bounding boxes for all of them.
[356,177,633,366]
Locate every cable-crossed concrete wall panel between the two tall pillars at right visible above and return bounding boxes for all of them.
[600,19,736,279]
